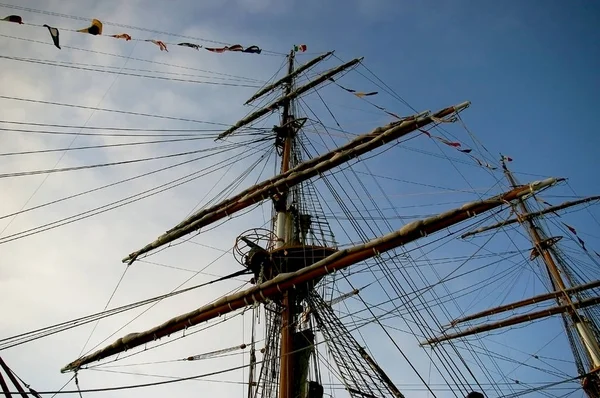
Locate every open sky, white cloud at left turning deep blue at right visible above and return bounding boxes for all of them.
[0,0,600,397]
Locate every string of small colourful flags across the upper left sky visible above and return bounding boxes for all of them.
[1,15,262,54]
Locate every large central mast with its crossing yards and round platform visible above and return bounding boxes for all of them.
[61,51,576,398]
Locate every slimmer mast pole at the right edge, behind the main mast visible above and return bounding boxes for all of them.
[502,158,600,398]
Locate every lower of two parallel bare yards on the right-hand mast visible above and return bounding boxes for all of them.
[421,292,600,345]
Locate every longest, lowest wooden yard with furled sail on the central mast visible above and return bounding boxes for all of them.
[61,178,563,373]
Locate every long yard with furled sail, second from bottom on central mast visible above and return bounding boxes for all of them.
[122,102,470,264]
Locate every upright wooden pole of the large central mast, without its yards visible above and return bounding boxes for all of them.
[274,50,295,398]
